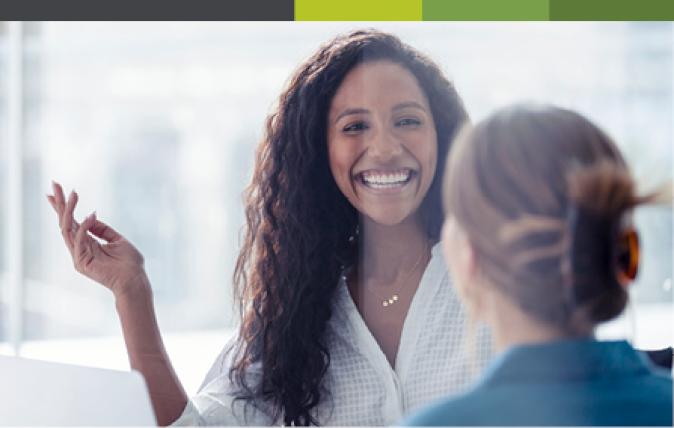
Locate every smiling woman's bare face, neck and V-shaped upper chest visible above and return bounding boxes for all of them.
[328,60,438,366]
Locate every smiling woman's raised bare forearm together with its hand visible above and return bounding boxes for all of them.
[47,183,187,426]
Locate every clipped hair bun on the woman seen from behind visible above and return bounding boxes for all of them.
[567,160,642,323]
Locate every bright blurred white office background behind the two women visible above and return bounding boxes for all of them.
[0,22,674,392]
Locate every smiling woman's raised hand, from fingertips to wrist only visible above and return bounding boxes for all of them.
[47,182,149,297]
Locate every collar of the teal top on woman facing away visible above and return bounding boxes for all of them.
[481,339,649,386]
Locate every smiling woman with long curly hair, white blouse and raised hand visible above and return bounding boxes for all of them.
[49,30,489,425]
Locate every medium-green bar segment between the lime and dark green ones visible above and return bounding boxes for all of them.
[423,0,548,21]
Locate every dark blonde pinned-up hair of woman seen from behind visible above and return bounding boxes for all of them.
[444,105,646,334]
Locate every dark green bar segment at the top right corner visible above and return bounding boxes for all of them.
[550,0,674,21]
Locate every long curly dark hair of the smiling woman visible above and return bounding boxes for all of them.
[229,30,467,425]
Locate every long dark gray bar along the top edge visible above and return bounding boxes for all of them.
[0,0,295,21]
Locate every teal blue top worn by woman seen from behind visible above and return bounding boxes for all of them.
[403,339,672,426]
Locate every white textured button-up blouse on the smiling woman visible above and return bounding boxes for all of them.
[174,245,492,425]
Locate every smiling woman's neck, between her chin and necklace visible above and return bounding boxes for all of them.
[358,218,430,282]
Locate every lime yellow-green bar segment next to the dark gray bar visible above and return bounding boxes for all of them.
[295,0,422,21]
